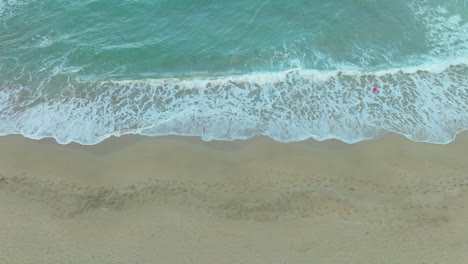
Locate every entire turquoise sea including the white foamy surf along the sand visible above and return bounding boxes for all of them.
[0,0,468,144]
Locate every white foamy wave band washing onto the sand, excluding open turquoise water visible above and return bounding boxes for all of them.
[0,62,468,144]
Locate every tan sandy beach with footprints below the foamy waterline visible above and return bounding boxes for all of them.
[0,134,468,264]
